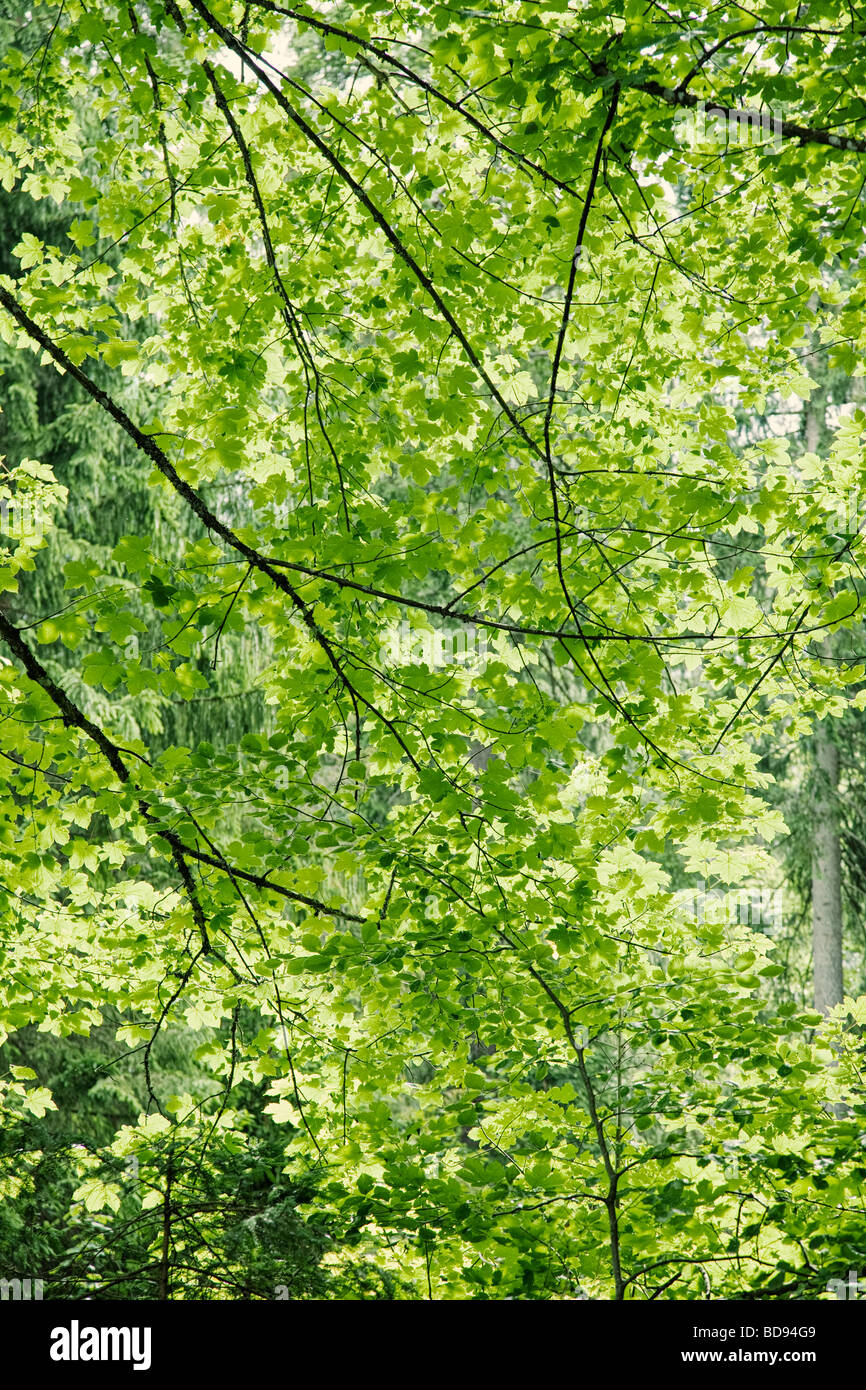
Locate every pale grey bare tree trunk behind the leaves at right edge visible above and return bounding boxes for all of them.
[812,720,842,1013]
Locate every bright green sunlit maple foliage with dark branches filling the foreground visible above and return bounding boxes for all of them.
[0,0,866,1300]
